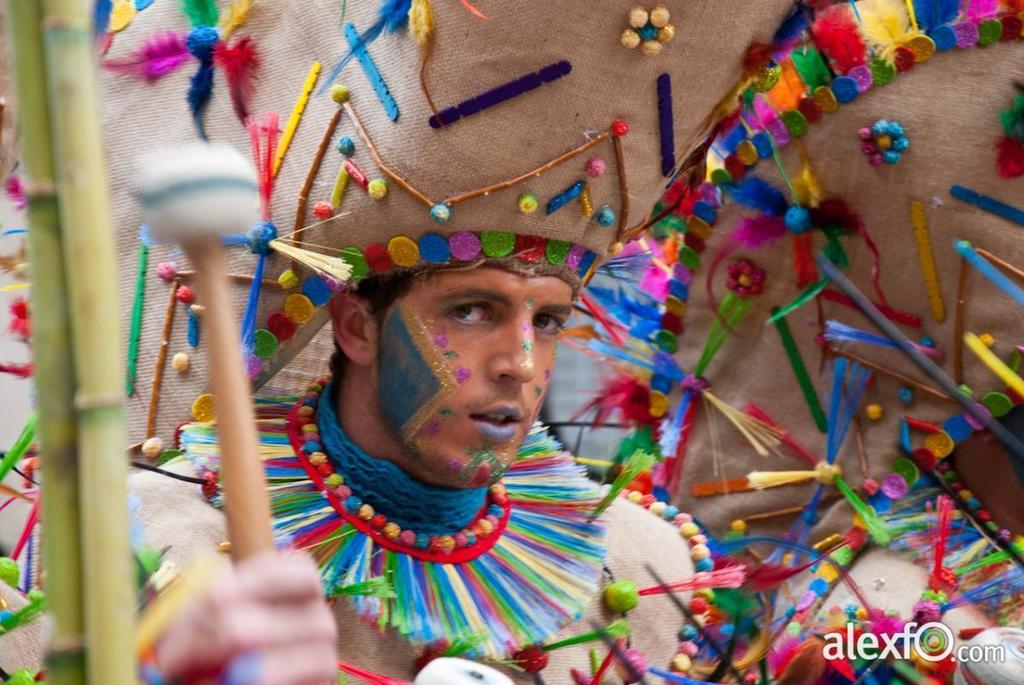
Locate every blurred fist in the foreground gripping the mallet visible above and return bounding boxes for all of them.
[157,553,337,685]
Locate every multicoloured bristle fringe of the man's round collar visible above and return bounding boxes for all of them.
[181,397,605,658]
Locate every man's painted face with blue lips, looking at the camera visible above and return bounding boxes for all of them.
[374,267,572,487]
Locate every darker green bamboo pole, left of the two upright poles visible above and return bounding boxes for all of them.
[6,0,86,685]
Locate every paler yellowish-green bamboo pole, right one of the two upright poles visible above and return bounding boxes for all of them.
[39,0,135,685]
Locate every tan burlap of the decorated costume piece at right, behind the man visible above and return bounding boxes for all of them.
[680,38,1024,540]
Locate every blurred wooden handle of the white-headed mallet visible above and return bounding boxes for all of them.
[184,237,273,561]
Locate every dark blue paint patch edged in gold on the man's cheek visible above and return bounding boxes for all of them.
[377,307,455,440]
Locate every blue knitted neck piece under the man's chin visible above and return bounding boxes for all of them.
[316,386,487,536]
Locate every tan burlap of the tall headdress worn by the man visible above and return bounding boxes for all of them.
[64,0,790,441]
